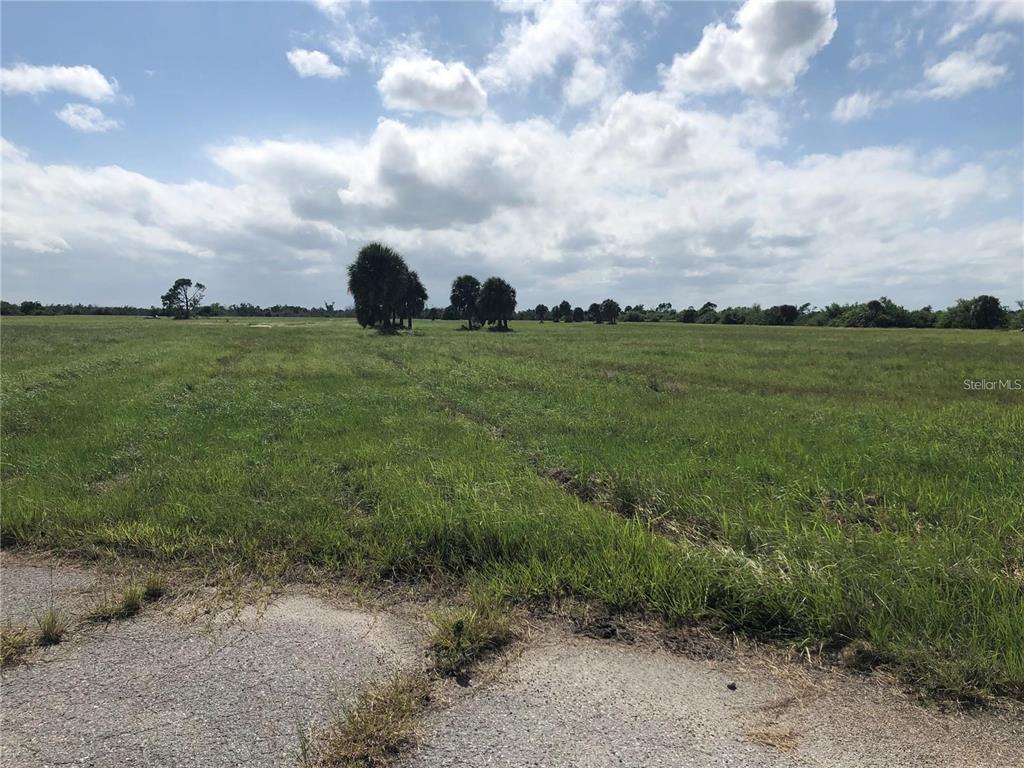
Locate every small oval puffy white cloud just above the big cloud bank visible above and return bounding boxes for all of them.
[377,56,487,117]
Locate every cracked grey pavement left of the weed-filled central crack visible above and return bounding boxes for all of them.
[0,558,422,768]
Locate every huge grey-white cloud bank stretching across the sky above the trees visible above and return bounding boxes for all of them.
[2,84,1024,303]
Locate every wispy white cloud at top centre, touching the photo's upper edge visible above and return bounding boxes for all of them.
[480,0,626,90]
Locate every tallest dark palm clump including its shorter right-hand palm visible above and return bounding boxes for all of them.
[348,243,427,330]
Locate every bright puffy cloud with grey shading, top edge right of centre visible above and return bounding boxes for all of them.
[662,0,837,95]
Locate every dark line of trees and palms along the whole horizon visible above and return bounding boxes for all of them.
[0,250,1024,331]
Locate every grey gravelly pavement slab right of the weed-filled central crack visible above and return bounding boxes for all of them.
[409,633,1024,768]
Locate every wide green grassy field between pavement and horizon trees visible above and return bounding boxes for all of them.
[0,317,1024,695]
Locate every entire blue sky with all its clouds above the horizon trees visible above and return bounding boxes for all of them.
[0,0,1024,307]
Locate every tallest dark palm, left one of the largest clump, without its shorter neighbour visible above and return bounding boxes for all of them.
[348,243,409,328]
